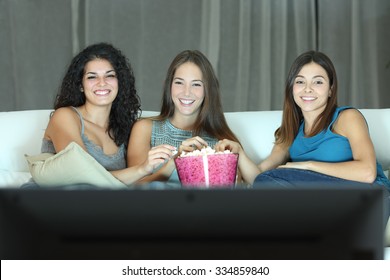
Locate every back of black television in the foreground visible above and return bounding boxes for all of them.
[0,186,384,260]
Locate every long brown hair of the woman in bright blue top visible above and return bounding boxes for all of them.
[275,51,337,147]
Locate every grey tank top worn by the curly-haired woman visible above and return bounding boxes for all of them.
[41,107,126,171]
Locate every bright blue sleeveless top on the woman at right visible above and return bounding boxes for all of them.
[289,106,390,188]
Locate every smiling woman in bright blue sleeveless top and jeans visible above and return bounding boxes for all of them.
[218,51,390,189]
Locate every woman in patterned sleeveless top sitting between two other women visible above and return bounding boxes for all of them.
[127,50,238,183]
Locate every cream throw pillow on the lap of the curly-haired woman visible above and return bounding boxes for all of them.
[25,142,126,189]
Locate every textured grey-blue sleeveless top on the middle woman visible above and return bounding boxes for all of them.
[150,119,218,183]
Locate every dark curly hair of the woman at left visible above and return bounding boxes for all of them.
[54,43,141,147]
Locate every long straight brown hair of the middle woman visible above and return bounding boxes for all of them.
[154,50,238,142]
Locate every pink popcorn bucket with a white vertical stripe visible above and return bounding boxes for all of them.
[175,153,238,189]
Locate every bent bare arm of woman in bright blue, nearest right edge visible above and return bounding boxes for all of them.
[282,110,376,183]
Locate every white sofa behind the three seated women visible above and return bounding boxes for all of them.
[0,109,390,246]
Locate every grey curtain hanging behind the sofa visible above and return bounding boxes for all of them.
[0,0,390,111]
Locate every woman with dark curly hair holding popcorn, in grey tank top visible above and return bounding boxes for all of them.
[42,43,174,185]
